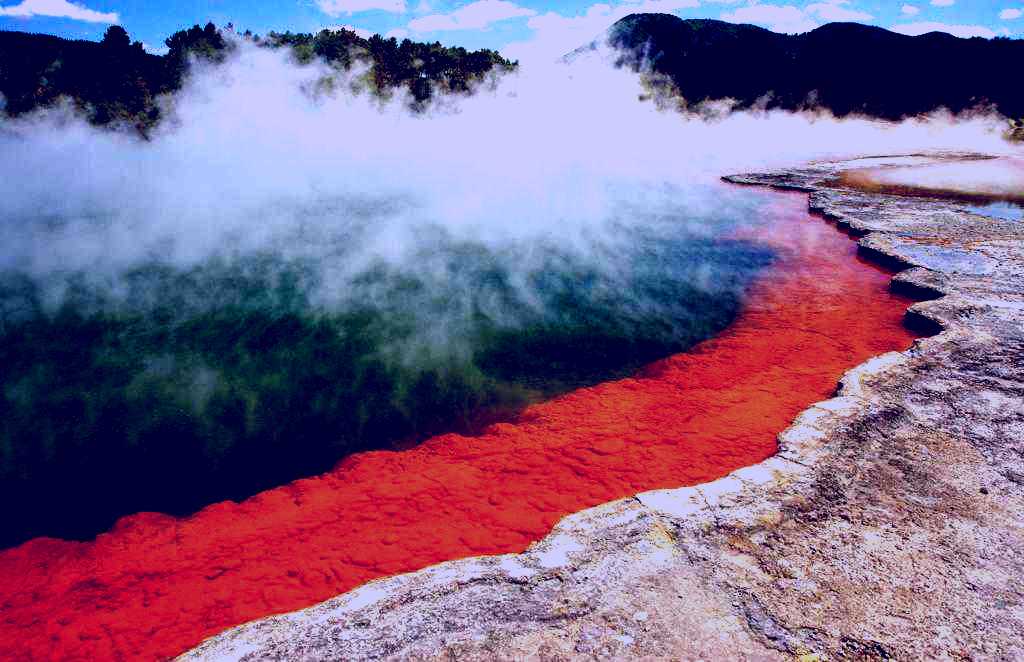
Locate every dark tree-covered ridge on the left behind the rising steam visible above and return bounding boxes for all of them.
[0,24,516,132]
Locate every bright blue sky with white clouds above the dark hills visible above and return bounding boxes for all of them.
[0,0,1024,58]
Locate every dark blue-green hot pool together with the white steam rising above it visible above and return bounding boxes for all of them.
[0,37,1006,542]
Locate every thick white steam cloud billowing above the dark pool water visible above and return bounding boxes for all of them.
[0,42,1007,329]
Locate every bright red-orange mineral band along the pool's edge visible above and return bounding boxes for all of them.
[0,189,913,661]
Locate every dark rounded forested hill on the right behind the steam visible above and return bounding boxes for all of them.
[609,14,1024,120]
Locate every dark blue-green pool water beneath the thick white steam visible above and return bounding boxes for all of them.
[0,209,773,547]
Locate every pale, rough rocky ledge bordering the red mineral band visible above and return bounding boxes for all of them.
[182,155,1024,660]
